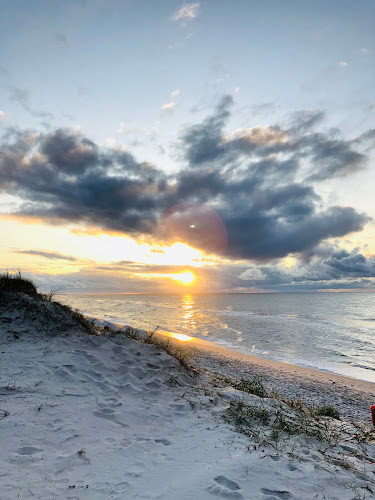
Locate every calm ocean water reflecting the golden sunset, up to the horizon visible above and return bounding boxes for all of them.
[57,292,375,382]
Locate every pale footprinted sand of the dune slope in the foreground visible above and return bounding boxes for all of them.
[0,296,375,500]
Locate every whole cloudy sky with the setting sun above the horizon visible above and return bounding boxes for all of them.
[0,0,375,293]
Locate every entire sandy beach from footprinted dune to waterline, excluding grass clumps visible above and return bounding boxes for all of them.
[0,292,375,500]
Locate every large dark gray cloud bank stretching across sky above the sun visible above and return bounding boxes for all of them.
[0,96,373,261]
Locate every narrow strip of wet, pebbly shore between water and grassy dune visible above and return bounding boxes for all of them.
[95,318,375,424]
